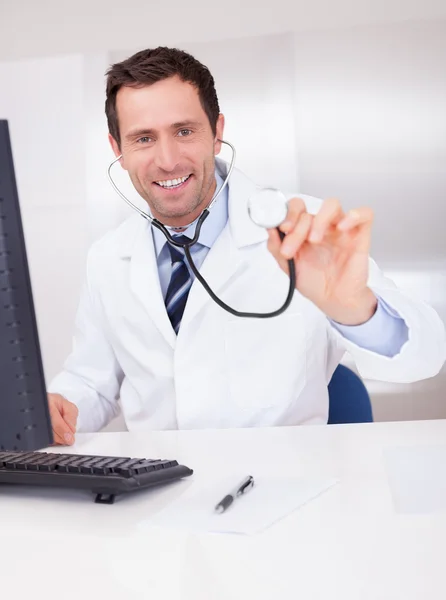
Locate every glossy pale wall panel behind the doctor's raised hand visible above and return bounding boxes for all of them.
[295,19,446,419]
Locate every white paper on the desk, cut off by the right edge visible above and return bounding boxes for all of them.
[384,445,446,514]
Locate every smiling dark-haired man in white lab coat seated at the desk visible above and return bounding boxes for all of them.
[49,48,445,444]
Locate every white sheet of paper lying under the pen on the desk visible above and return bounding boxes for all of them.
[145,476,337,535]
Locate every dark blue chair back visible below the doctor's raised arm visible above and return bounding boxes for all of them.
[328,365,373,424]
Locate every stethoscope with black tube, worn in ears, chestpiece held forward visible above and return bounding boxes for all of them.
[107,140,296,319]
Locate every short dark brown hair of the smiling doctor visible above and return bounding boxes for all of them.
[105,46,220,146]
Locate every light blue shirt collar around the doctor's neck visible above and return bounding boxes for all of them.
[151,171,228,258]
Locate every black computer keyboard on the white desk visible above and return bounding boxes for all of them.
[0,452,193,504]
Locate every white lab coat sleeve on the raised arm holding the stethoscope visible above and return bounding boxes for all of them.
[327,259,446,383]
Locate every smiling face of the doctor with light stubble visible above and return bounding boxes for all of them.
[110,77,224,227]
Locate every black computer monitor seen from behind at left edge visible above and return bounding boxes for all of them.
[0,120,53,451]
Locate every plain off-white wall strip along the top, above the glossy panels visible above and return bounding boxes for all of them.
[0,0,446,60]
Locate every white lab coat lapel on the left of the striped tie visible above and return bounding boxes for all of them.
[130,220,176,348]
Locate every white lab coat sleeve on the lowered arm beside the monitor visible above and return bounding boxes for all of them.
[48,255,123,432]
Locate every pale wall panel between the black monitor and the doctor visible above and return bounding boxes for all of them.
[0,56,86,381]
